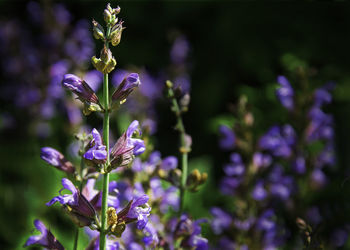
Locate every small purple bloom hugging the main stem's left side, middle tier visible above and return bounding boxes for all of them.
[83,128,107,163]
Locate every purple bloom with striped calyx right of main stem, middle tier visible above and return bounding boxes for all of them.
[110,120,146,168]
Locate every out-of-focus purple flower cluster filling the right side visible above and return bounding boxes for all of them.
[211,72,347,249]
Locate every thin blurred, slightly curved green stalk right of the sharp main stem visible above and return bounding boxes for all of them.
[168,88,189,213]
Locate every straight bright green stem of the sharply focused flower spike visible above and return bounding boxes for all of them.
[100,26,111,250]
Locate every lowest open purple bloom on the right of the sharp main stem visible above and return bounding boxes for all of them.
[126,194,151,229]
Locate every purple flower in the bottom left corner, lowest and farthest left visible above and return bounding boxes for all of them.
[24,220,64,250]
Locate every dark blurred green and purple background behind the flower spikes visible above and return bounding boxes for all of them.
[0,1,350,249]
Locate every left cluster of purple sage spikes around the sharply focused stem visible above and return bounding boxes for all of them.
[25,4,209,249]
